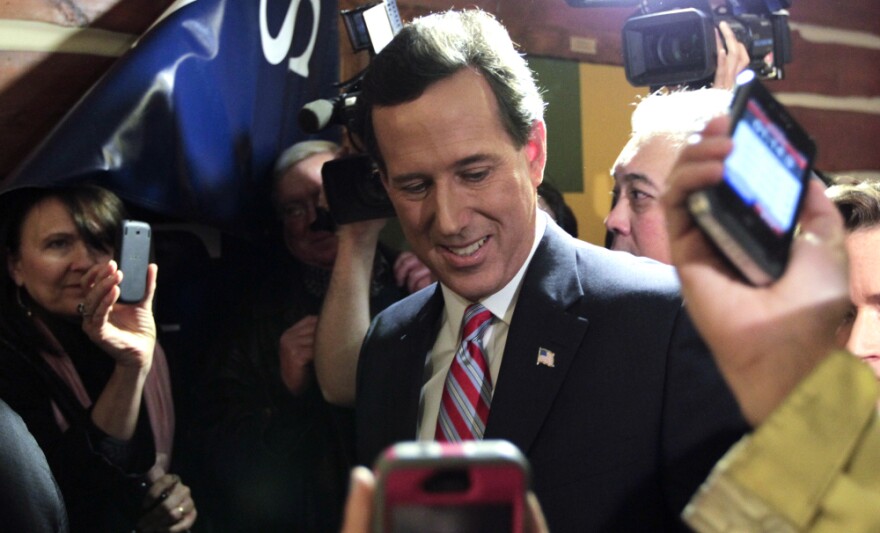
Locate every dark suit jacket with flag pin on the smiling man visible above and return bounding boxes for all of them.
[356,224,747,533]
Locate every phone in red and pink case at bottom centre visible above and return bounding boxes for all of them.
[373,440,530,533]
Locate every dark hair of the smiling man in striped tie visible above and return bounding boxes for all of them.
[353,9,544,169]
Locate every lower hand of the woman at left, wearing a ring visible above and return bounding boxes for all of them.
[137,474,199,533]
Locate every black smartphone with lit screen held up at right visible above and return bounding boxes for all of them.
[688,70,816,286]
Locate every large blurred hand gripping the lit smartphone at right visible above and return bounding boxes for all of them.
[663,117,850,426]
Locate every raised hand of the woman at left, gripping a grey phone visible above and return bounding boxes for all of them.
[80,261,158,371]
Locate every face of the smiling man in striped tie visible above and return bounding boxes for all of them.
[373,69,546,301]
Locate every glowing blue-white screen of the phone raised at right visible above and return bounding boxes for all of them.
[724,98,809,236]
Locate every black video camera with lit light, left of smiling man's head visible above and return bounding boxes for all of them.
[297,0,403,224]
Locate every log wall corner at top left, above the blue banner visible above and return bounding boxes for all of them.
[0,0,172,181]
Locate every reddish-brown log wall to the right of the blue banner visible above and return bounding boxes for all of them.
[341,0,880,174]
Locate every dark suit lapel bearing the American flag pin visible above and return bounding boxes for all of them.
[485,224,588,453]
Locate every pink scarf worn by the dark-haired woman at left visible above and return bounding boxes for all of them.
[37,321,174,481]
